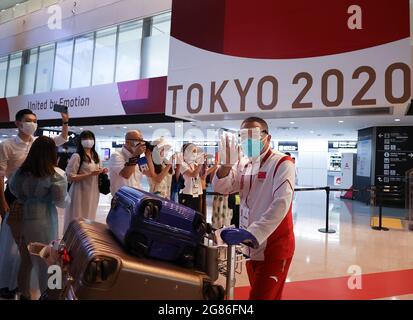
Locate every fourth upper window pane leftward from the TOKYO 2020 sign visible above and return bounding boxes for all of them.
[71,33,93,88]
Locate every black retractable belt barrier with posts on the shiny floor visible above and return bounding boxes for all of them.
[206,186,382,233]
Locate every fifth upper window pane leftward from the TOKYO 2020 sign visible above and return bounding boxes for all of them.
[53,39,73,91]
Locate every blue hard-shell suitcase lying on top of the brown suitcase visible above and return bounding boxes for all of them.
[106,187,207,267]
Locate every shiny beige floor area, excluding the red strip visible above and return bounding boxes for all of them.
[55,191,413,299]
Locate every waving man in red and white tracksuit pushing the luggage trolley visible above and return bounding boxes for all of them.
[212,117,295,300]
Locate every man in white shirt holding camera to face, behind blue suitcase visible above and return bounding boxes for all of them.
[109,130,154,196]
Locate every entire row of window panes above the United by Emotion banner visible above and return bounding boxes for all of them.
[0,10,171,98]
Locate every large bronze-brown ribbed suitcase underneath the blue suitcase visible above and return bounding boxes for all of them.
[39,220,224,300]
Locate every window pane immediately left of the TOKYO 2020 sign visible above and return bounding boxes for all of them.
[142,13,171,78]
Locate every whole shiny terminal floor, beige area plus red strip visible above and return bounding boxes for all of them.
[14,191,413,299]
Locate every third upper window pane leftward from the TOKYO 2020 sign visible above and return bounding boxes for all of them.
[92,27,117,85]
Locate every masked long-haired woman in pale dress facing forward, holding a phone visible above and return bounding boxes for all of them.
[63,131,108,231]
